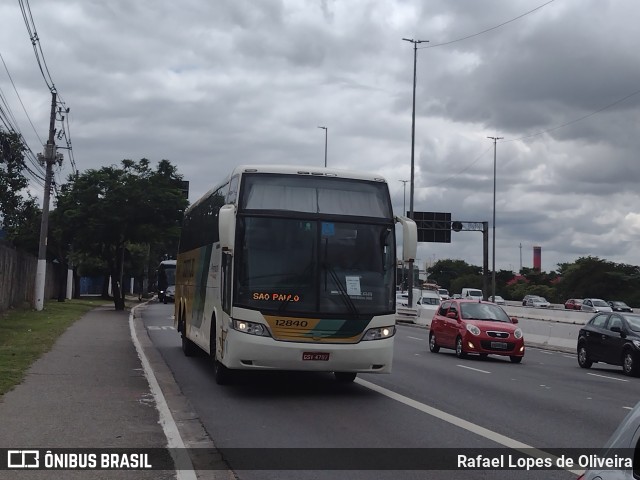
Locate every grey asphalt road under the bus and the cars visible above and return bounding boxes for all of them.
[142,304,640,480]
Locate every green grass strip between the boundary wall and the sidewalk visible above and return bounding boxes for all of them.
[0,298,113,399]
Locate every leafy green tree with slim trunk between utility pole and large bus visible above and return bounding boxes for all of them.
[56,158,188,310]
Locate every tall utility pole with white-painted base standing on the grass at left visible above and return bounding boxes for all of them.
[35,90,56,311]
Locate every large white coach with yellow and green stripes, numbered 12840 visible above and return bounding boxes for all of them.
[175,166,417,384]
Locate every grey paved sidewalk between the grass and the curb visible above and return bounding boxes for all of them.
[0,306,178,480]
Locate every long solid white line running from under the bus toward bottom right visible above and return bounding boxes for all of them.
[355,378,584,475]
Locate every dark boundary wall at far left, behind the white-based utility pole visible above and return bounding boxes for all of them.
[0,244,58,312]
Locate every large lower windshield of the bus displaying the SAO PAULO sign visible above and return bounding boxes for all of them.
[234,216,395,316]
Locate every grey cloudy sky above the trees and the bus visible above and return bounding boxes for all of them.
[0,0,640,271]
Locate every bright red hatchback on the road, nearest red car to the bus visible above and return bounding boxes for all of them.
[429,300,524,363]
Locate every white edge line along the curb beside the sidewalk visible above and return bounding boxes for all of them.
[129,305,198,480]
